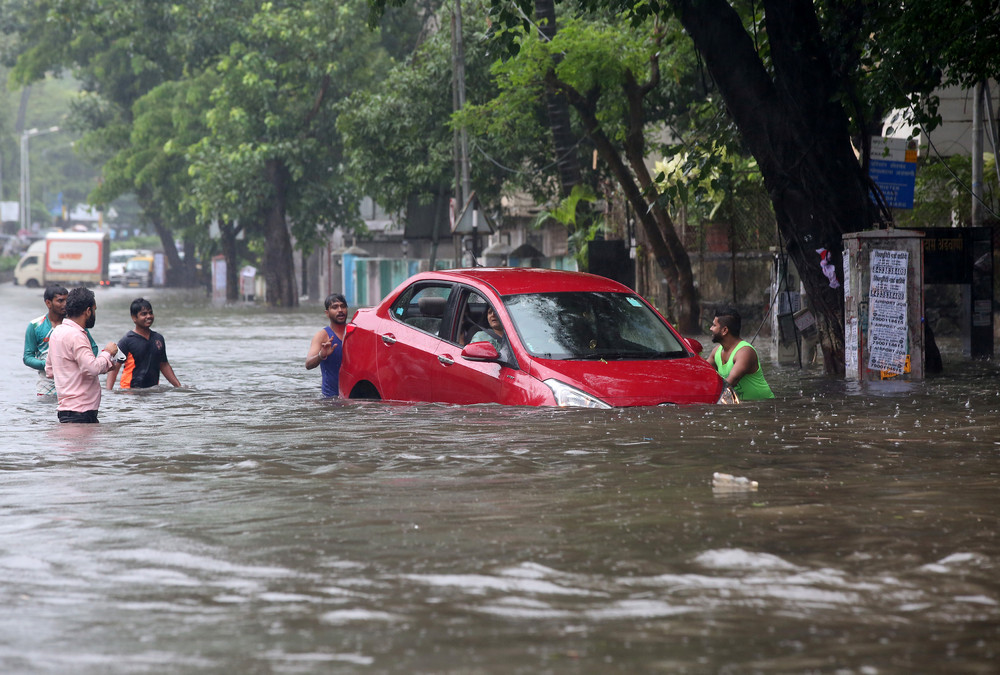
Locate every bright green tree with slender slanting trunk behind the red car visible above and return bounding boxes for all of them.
[461,18,698,332]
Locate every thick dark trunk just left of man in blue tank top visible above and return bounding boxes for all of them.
[263,159,299,307]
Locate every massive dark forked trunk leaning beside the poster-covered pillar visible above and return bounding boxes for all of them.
[673,0,873,374]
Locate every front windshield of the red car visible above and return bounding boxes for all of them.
[504,292,688,360]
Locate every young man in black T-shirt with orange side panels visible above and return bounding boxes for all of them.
[107,298,181,391]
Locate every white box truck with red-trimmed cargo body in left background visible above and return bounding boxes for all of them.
[14,232,111,288]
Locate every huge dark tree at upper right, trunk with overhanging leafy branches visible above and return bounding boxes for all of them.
[371,0,1000,373]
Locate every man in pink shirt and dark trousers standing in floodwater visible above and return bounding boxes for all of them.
[45,288,118,423]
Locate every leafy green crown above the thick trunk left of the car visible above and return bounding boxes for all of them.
[189,0,386,251]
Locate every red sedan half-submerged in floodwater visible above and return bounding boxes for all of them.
[340,267,735,408]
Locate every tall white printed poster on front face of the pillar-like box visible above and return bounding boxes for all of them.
[868,249,909,375]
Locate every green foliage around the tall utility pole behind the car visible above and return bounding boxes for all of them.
[338,2,551,217]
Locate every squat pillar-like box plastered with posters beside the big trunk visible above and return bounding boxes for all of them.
[843,228,924,382]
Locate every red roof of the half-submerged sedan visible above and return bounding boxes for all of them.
[422,267,633,295]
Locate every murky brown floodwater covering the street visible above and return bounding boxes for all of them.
[0,284,1000,675]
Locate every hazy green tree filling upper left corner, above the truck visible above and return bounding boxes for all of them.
[0,0,250,280]
